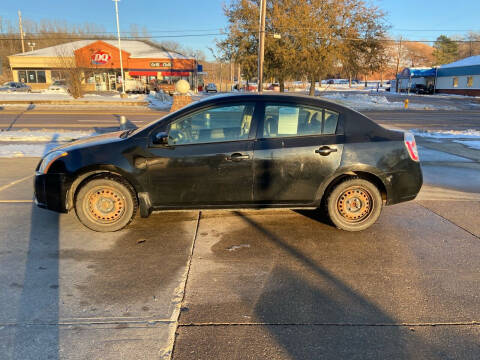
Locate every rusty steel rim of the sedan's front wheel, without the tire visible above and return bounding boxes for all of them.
[84,186,125,224]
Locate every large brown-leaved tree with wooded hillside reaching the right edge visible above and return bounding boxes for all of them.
[217,0,480,94]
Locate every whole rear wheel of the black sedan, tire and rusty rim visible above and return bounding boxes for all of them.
[325,178,383,231]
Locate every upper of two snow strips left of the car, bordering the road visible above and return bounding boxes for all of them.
[0,129,98,142]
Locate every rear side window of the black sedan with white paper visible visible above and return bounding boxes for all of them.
[263,104,339,138]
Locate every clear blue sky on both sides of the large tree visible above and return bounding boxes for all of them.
[0,0,480,59]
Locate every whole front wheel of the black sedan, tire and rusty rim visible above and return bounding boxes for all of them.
[75,175,138,232]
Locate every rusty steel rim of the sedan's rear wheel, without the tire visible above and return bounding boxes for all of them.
[337,187,373,223]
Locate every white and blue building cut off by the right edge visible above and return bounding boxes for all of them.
[436,55,480,96]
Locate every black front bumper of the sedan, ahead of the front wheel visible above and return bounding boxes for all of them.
[34,173,68,213]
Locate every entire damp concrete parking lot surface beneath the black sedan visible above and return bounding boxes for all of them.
[0,148,480,360]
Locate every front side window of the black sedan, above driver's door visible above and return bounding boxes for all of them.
[168,104,255,145]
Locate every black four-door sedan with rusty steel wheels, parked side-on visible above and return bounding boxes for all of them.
[35,94,422,231]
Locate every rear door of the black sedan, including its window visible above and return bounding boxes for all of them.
[253,103,343,206]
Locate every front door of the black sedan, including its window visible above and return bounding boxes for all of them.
[147,102,256,207]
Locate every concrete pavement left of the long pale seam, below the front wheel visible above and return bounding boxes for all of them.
[0,158,198,360]
